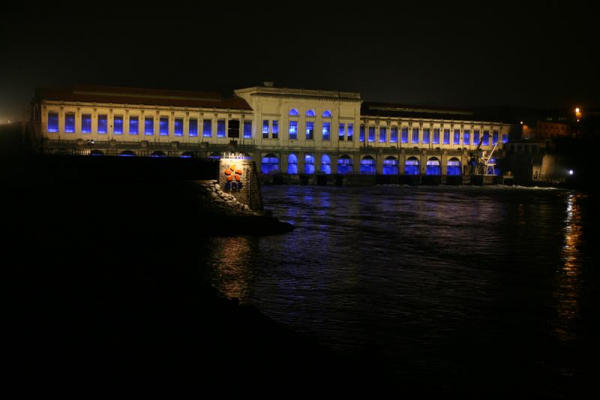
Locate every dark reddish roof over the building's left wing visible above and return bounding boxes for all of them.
[35,85,251,110]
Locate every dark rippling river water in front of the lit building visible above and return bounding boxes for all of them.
[197,186,599,398]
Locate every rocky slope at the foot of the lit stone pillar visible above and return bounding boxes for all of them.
[186,181,294,235]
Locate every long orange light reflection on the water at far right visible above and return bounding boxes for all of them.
[553,194,583,342]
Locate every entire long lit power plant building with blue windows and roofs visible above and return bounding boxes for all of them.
[32,83,511,183]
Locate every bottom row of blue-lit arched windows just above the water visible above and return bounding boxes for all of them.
[261,153,462,175]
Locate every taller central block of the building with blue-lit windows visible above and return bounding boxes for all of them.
[235,83,362,175]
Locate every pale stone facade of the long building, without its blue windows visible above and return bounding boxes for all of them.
[41,87,510,174]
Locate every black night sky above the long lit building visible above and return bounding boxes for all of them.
[0,1,600,122]
